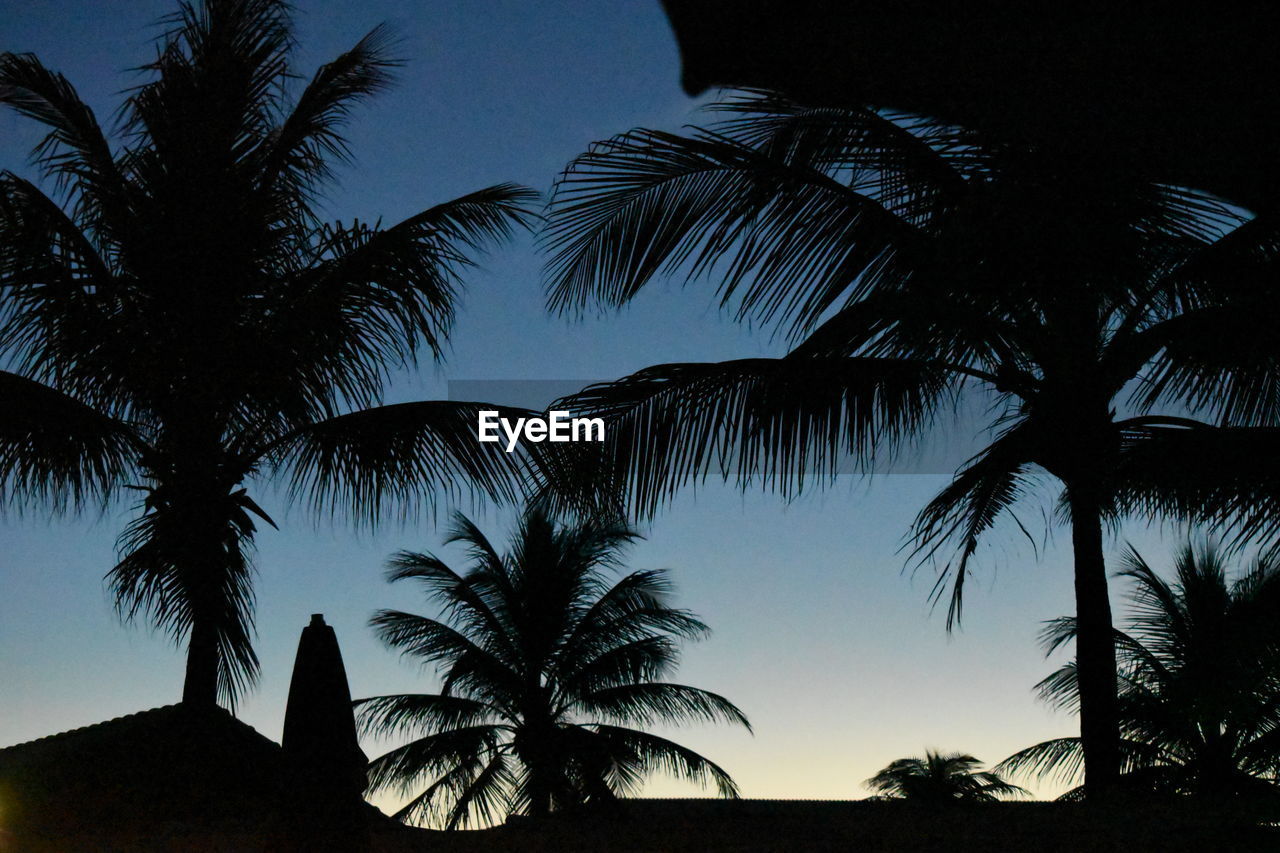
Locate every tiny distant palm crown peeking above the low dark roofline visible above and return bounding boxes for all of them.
[864,749,1027,804]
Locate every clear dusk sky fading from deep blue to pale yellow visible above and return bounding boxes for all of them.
[0,0,1174,799]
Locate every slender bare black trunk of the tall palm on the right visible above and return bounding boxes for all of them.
[1068,478,1120,799]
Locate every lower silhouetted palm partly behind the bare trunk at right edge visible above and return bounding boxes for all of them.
[998,544,1280,802]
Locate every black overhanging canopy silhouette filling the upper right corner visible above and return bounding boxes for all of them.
[663,0,1280,209]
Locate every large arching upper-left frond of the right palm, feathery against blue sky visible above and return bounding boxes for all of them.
[544,128,922,333]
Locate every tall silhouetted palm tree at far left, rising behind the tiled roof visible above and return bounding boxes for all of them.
[0,0,534,703]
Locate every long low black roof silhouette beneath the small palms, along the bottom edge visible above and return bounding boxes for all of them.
[394,799,1280,853]
